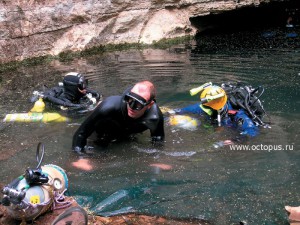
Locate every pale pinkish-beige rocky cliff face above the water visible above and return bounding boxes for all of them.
[0,0,286,63]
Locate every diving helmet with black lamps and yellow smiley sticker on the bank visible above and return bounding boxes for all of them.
[2,143,72,221]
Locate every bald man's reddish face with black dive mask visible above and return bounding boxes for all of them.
[125,86,153,119]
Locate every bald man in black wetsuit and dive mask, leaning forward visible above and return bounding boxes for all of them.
[72,81,164,153]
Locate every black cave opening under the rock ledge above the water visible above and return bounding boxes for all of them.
[190,0,300,32]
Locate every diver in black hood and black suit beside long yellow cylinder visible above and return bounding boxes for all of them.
[31,72,101,113]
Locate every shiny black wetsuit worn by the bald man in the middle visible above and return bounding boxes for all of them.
[72,96,164,149]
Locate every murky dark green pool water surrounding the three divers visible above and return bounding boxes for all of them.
[0,29,300,224]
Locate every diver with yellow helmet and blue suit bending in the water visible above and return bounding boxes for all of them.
[173,82,268,137]
